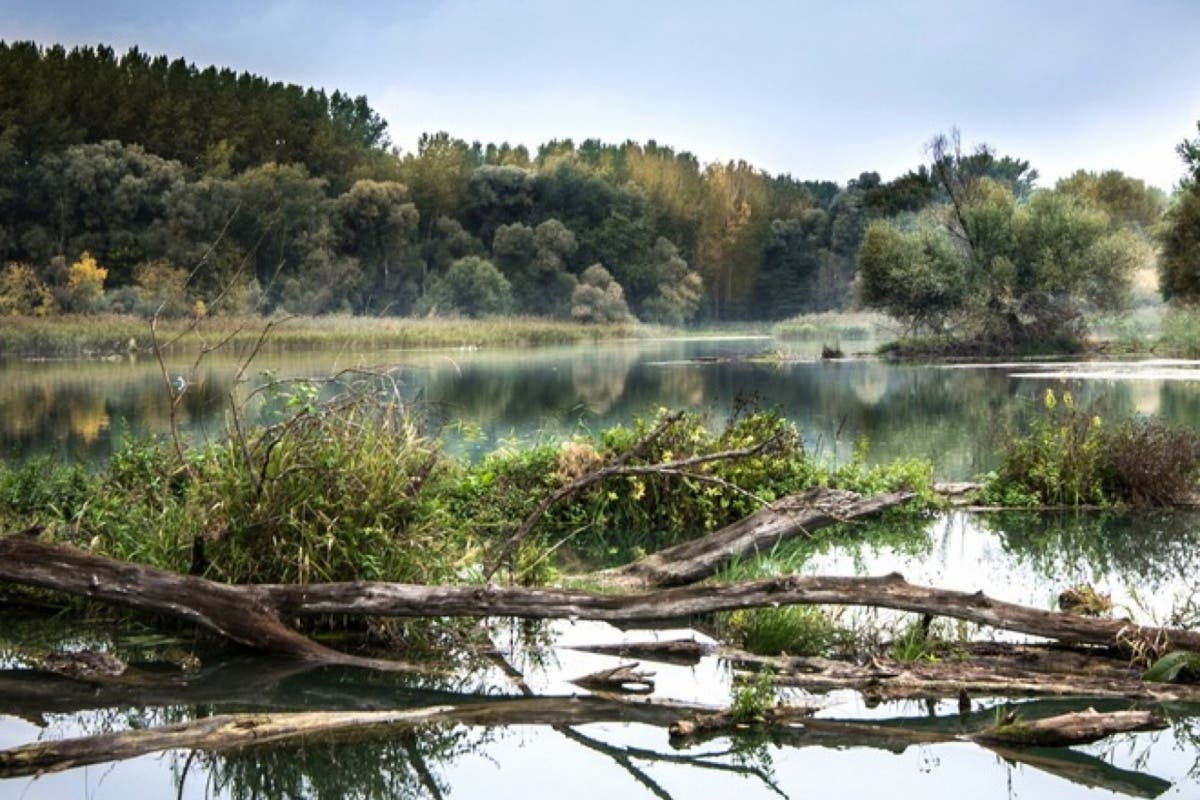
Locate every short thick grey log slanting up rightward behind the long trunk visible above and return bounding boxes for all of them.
[594,488,917,587]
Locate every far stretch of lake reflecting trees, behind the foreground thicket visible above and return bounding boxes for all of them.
[7,339,1200,480]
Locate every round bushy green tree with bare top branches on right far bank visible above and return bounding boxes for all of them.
[858,131,1153,351]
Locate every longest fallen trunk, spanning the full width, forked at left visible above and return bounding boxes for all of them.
[0,536,1200,669]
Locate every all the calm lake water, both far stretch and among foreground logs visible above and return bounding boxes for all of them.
[0,339,1200,800]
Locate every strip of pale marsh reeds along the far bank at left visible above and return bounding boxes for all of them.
[0,314,670,357]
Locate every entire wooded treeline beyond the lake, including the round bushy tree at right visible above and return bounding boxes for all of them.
[0,42,1200,345]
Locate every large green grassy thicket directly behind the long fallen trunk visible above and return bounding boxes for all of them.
[0,402,930,592]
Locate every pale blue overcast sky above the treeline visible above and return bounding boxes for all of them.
[0,0,1200,188]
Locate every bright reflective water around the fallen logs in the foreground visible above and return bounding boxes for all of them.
[0,513,1200,800]
